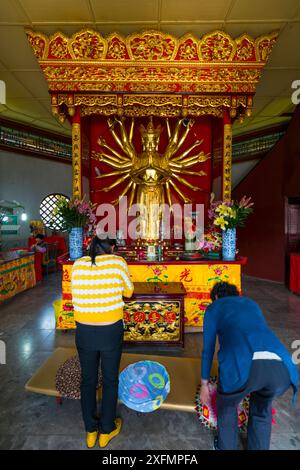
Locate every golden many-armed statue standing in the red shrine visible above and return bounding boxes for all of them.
[92,117,210,239]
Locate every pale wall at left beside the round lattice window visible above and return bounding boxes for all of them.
[0,150,72,248]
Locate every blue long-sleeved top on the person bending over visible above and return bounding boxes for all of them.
[201,296,298,393]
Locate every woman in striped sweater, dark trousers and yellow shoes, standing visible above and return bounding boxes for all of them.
[72,236,133,448]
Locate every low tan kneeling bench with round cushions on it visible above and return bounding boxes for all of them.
[25,348,217,412]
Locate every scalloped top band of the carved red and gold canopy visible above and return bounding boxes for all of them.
[26,29,278,63]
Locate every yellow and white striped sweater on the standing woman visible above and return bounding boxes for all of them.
[72,255,133,324]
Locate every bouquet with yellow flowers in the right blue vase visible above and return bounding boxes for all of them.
[208,196,253,230]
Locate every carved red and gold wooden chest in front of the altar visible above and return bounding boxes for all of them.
[124,282,186,347]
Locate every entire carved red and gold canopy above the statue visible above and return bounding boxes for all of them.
[26,29,277,117]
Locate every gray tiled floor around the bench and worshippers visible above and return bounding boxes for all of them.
[0,273,300,450]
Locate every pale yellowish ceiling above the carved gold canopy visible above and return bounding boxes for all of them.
[0,0,300,134]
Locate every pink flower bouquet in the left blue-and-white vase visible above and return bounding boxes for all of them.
[53,196,97,232]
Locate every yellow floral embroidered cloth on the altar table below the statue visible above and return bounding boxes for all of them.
[56,257,247,330]
